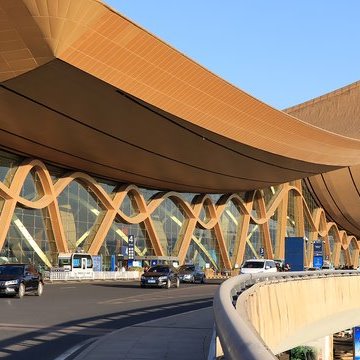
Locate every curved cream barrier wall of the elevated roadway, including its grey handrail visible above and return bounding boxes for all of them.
[214,271,360,360]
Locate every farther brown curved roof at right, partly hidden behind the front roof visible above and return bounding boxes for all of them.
[286,81,360,238]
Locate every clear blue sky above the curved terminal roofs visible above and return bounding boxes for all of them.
[104,0,360,109]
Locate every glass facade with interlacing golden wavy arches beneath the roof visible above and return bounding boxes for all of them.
[0,151,359,271]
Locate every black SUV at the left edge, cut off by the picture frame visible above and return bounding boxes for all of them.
[0,264,44,298]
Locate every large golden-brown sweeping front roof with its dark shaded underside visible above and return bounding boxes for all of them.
[0,0,360,192]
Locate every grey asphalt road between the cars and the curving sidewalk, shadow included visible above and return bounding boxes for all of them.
[0,281,218,360]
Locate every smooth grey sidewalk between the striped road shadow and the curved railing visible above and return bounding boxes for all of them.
[74,307,214,360]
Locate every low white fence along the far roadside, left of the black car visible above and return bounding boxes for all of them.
[44,271,141,281]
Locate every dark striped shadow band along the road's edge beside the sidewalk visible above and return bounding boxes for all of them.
[0,296,213,360]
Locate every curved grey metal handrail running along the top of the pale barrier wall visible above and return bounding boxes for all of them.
[212,270,360,360]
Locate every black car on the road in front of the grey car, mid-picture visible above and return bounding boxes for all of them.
[140,265,180,289]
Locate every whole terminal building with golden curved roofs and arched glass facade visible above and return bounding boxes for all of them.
[0,0,360,270]
